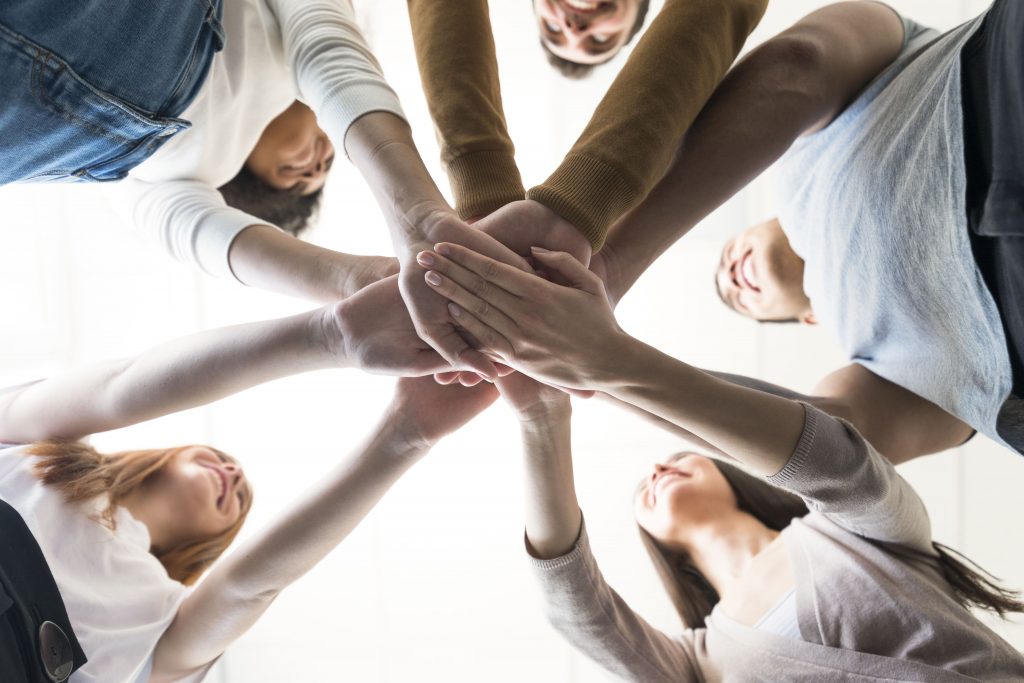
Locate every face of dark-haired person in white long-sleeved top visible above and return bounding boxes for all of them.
[246,101,334,195]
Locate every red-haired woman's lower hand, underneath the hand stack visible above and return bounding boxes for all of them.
[391,377,498,449]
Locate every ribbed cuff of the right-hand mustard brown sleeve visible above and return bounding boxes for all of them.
[526,154,640,252]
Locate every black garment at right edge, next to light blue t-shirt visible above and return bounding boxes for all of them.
[961,0,1024,450]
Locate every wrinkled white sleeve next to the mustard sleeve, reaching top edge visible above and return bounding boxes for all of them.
[267,0,406,146]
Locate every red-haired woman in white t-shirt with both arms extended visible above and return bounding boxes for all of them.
[0,302,497,683]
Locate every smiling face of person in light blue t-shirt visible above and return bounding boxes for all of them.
[715,219,814,323]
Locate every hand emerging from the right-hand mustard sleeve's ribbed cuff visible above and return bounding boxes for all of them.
[474,200,591,265]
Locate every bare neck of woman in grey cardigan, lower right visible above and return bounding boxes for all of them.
[684,510,778,597]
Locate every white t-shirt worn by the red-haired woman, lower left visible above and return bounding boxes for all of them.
[0,445,192,683]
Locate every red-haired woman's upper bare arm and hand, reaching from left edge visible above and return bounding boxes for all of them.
[0,278,446,443]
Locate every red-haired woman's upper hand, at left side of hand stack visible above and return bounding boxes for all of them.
[330,275,449,376]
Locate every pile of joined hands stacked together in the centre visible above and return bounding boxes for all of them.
[331,200,621,405]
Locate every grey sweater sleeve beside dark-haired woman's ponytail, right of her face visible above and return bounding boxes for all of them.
[768,403,932,553]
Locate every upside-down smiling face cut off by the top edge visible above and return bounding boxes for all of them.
[534,0,640,65]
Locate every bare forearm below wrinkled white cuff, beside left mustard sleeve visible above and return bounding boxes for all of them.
[345,112,452,255]
